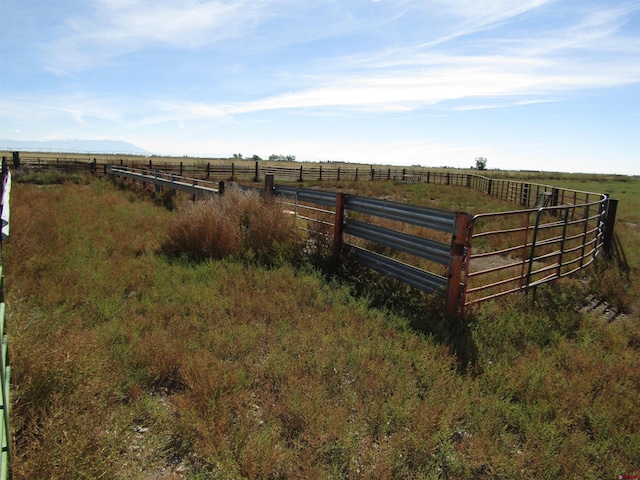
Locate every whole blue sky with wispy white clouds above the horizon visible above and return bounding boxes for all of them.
[0,0,640,174]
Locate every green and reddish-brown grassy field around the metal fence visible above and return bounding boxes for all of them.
[3,168,640,479]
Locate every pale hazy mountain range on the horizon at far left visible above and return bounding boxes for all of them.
[0,139,151,155]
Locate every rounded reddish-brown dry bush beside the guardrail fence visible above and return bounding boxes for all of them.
[163,189,302,263]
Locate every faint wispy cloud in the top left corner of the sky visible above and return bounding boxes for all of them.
[45,0,270,73]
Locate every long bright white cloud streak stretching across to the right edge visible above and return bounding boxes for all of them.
[148,49,640,118]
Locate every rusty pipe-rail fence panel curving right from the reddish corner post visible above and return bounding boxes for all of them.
[461,196,612,307]
